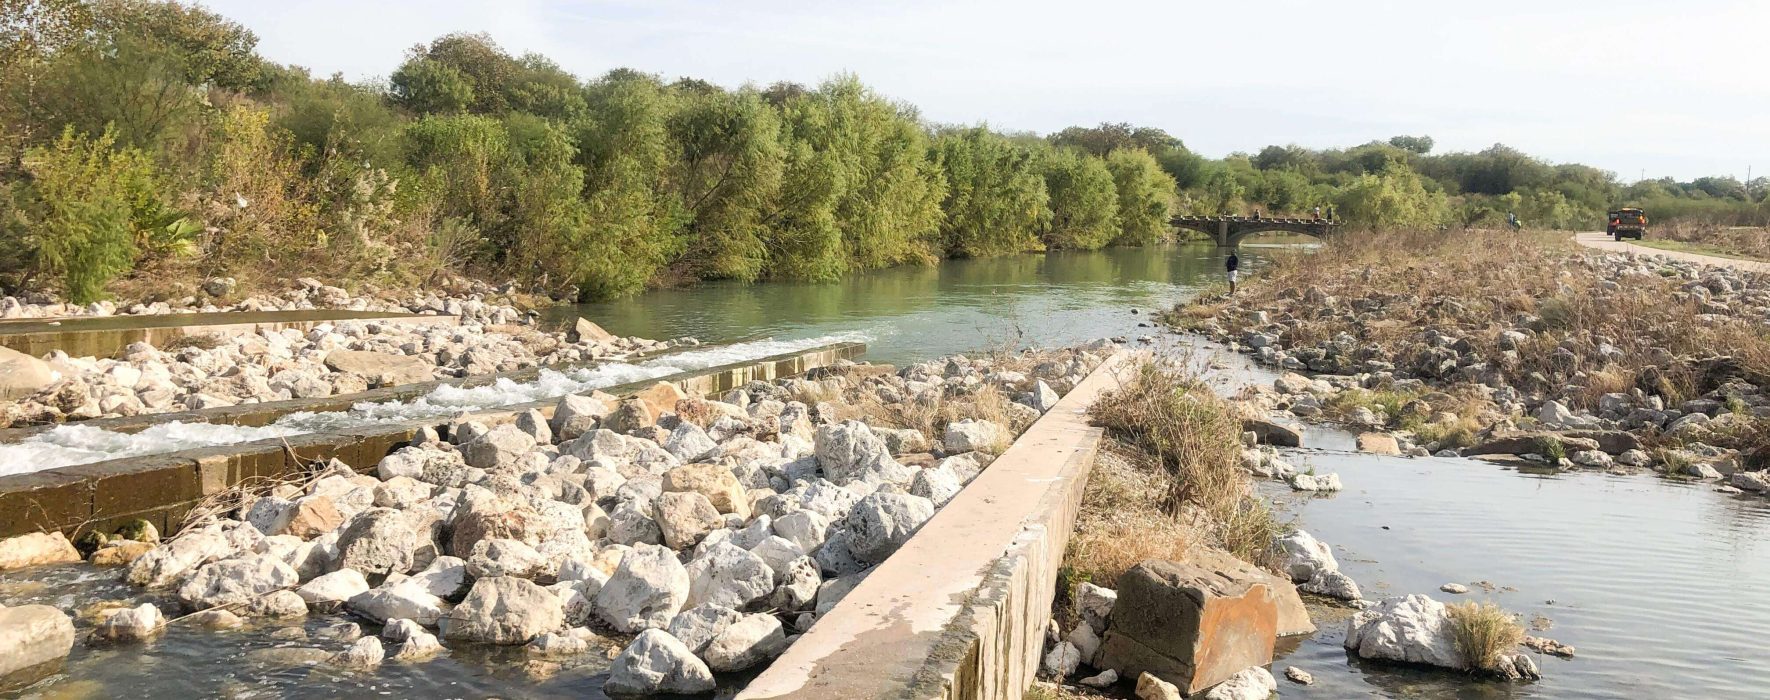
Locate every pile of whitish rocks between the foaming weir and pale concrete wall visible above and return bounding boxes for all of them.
[0,351,1099,696]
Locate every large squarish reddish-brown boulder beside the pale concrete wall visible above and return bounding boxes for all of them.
[1097,556,1278,695]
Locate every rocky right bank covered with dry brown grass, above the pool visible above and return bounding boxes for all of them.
[1166,226,1770,491]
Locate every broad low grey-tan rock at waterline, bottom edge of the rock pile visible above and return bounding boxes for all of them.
[443,576,565,645]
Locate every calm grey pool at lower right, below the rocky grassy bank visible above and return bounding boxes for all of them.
[1269,450,1770,698]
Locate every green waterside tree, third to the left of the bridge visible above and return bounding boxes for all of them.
[935,128,1051,257]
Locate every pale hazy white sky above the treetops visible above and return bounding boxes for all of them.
[204,0,1770,181]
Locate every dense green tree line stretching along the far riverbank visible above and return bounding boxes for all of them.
[0,0,1763,301]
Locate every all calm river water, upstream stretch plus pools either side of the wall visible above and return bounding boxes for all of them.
[0,245,1770,698]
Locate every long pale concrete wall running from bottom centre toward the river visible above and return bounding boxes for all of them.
[738,353,1126,700]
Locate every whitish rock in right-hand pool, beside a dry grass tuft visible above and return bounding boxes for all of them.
[1345,594,1464,668]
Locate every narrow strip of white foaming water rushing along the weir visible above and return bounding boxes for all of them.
[0,333,867,475]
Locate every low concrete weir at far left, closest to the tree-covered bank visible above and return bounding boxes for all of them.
[0,310,460,358]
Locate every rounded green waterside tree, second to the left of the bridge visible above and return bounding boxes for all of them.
[1039,149,1120,250]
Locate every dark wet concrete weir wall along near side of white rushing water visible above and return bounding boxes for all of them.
[0,342,866,537]
